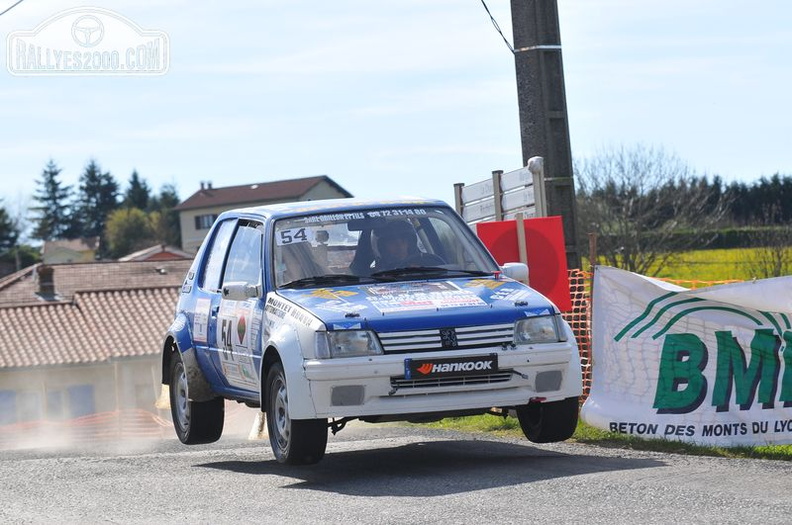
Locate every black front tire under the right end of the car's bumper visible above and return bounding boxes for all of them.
[515,397,578,443]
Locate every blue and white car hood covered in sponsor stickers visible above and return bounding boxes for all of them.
[278,277,557,332]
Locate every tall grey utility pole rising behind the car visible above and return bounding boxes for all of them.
[511,0,580,268]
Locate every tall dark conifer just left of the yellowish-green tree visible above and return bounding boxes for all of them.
[73,159,118,237]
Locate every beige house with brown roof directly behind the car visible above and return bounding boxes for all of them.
[179,175,352,254]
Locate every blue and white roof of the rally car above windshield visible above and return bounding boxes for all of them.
[220,197,450,219]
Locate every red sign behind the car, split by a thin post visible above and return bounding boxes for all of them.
[476,217,572,312]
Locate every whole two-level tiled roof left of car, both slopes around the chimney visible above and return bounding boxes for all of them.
[0,259,192,369]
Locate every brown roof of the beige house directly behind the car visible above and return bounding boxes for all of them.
[175,175,352,210]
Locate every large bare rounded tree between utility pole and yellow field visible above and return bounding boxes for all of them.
[574,145,726,275]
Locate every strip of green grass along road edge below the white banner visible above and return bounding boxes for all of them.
[424,414,792,461]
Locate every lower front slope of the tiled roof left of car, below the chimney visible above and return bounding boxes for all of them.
[0,287,179,369]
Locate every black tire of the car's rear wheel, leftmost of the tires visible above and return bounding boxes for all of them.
[170,352,225,445]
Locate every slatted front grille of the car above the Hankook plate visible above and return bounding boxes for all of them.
[378,323,514,354]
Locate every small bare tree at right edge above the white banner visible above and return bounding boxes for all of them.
[746,204,792,279]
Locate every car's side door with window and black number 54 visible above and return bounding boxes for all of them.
[214,220,264,392]
